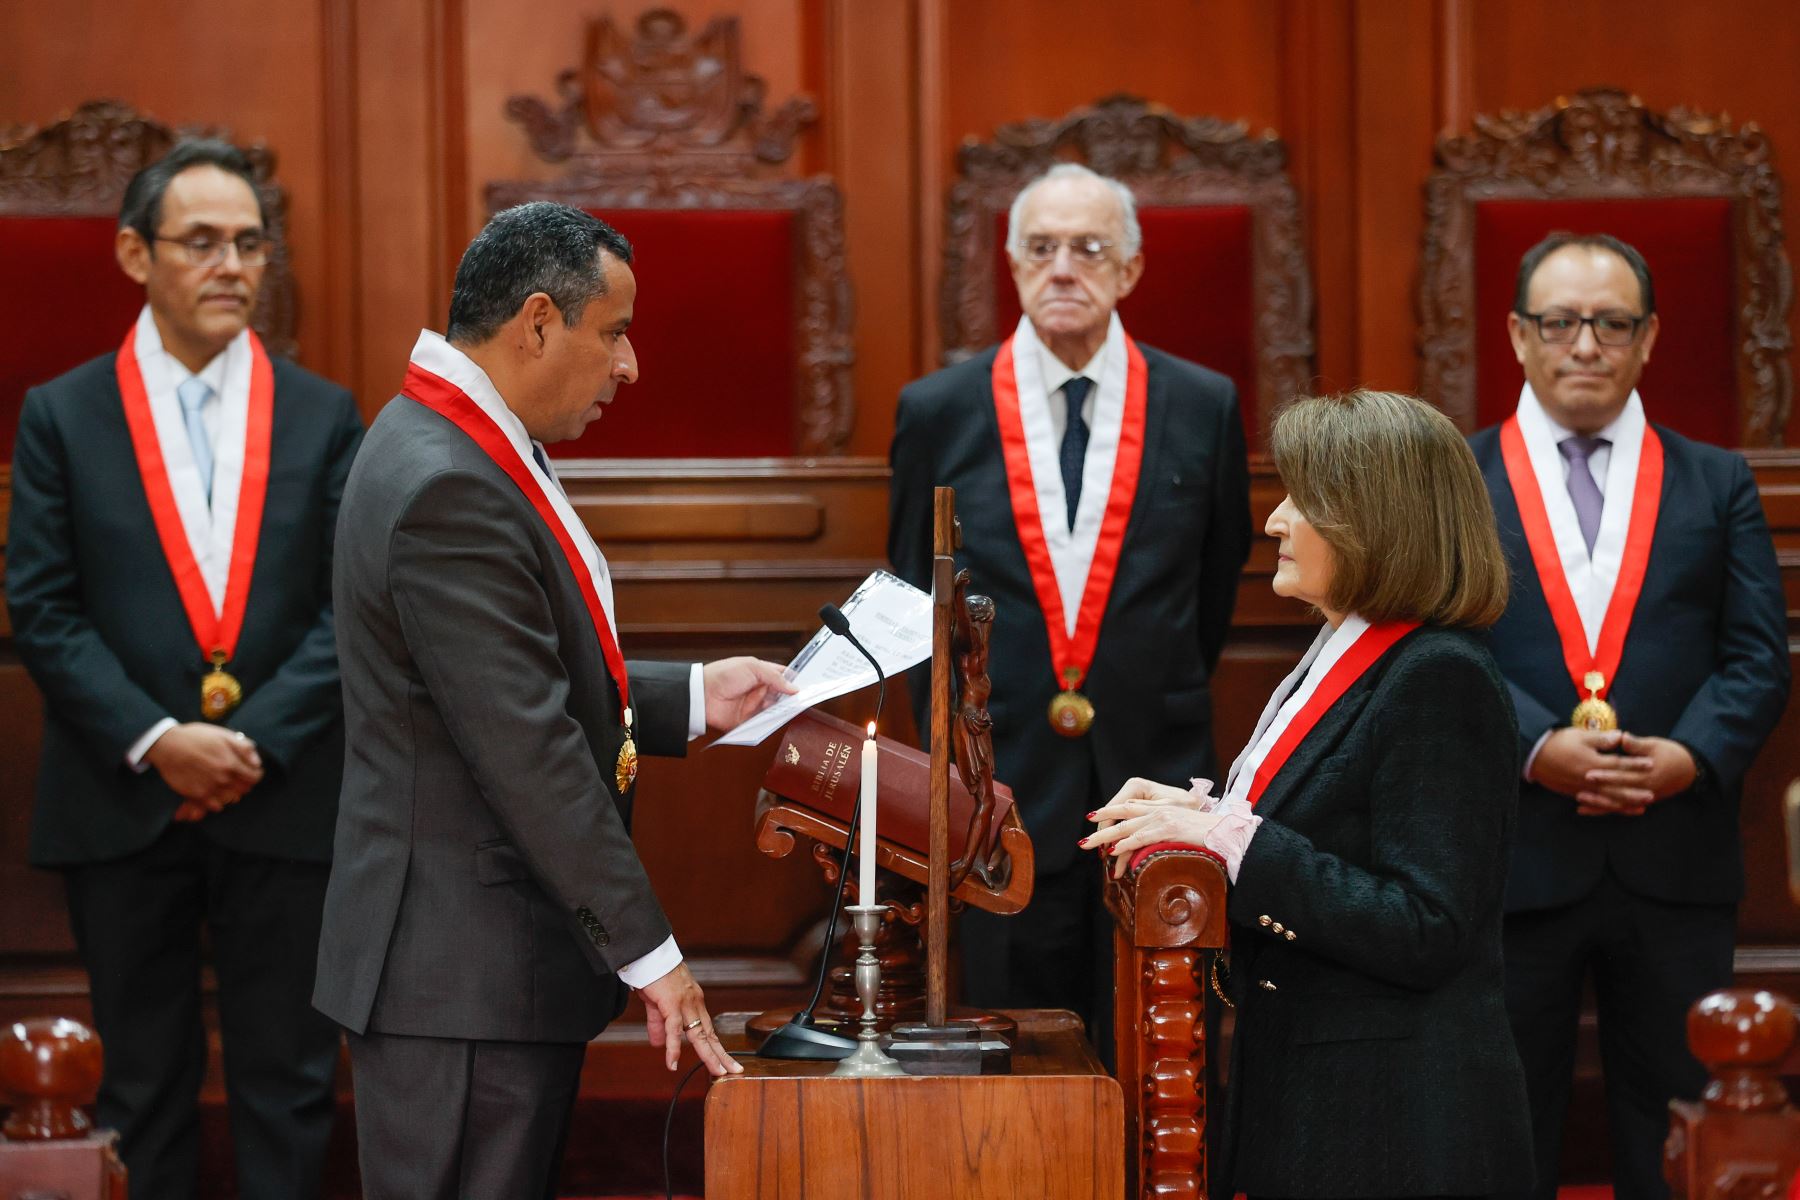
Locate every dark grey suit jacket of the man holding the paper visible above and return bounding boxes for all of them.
[313,398,689,1042]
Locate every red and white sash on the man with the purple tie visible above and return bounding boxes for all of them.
[1499,386,1663,700]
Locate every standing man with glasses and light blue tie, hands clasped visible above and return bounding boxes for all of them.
[5,140,362,1200]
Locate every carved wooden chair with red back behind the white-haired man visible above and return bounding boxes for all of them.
[941,95,1312,446]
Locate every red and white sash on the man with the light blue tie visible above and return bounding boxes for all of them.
[115,326,275,662]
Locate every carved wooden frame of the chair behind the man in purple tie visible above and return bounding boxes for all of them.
[1418,88,1793,446]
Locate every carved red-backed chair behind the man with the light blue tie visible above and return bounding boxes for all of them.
[0,101,293,459]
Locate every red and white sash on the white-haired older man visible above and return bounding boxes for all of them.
[994,314,1148,689]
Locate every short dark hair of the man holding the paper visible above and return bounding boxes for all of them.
[445,200,632,345]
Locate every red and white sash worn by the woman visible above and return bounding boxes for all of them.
[1224,613,1418,808]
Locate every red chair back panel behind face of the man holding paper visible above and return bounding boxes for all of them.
[551,209,797,459]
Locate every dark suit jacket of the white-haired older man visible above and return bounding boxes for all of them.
[887,342,1249,873]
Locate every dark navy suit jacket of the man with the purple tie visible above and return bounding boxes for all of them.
[1469,426,1787,910]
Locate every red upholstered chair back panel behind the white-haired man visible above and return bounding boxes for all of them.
[994,205,1258,446]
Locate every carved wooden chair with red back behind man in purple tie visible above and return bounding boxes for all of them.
[1418,88,1793,446]
